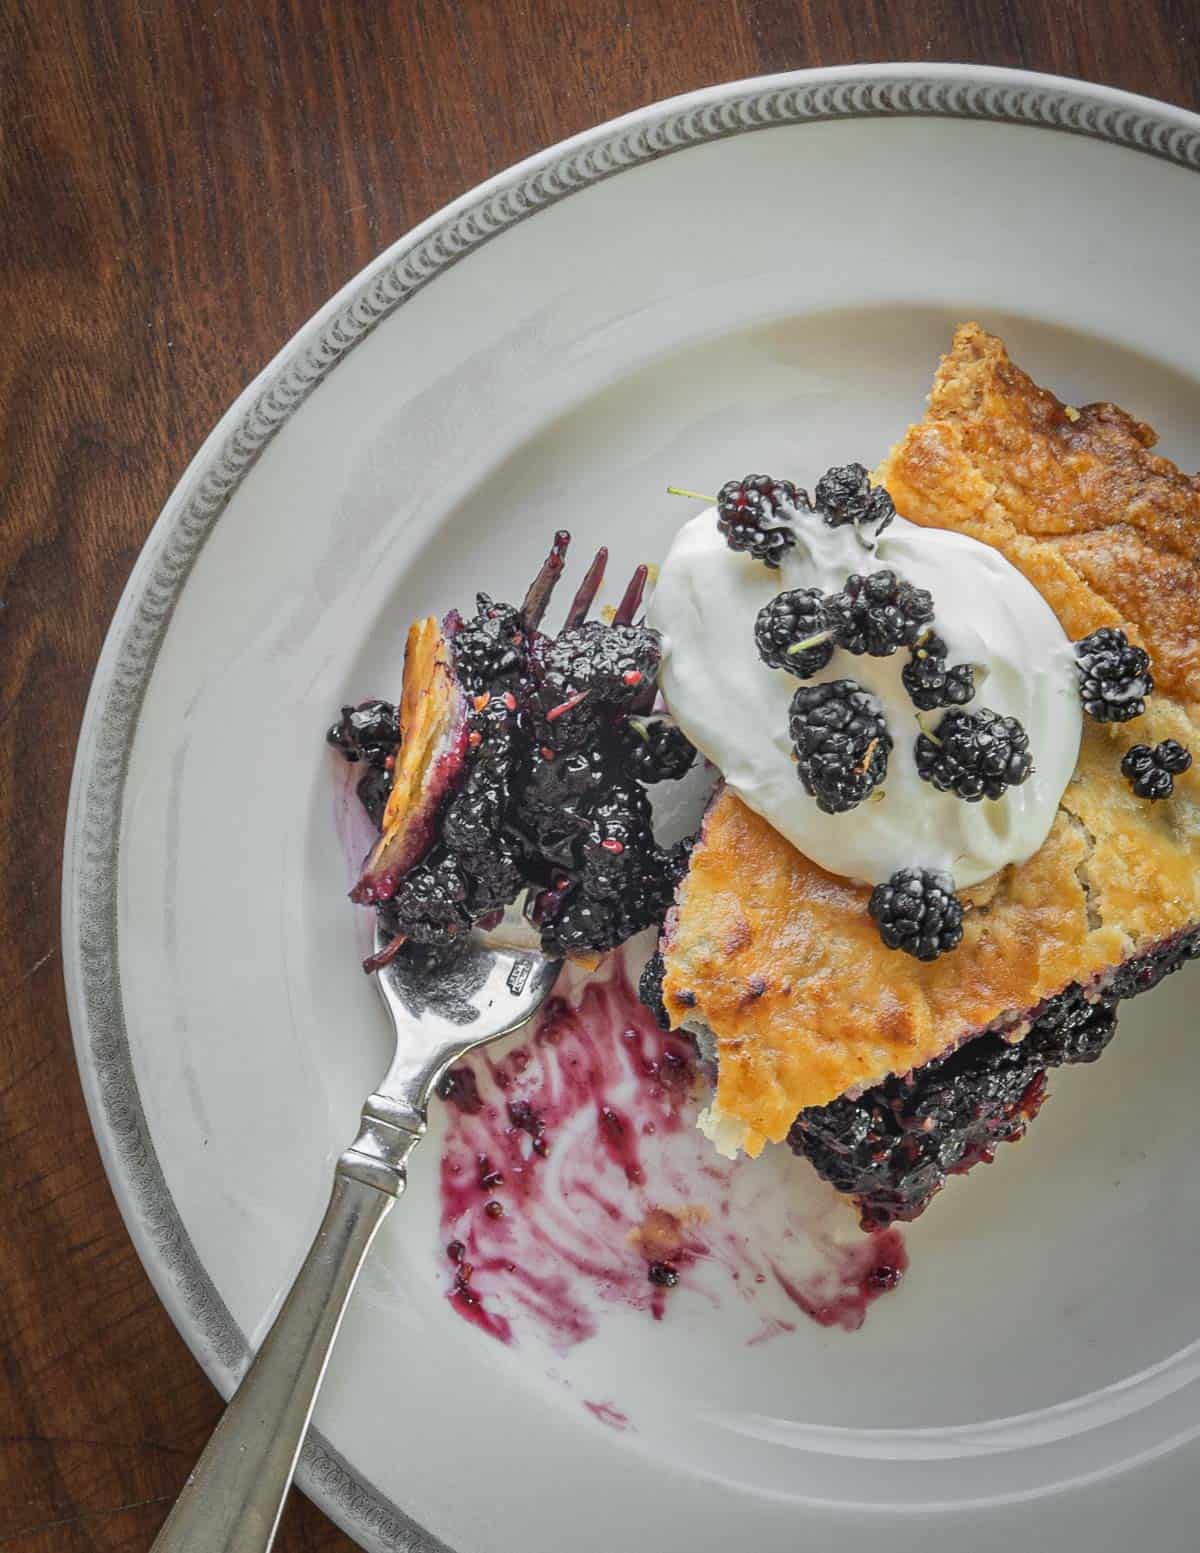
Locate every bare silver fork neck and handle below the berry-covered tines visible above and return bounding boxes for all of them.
[151,935,559,1553]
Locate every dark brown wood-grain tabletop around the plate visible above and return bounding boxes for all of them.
[0,0,1200,1553]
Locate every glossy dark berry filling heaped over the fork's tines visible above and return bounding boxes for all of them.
[329,534,695,968]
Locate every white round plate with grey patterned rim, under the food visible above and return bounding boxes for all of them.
[65,67,1200,1553]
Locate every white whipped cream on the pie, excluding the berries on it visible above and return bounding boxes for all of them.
[647,508,1082,888]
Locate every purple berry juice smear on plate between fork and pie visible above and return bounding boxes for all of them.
[438,954,908,1354]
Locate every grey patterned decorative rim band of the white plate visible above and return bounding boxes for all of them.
[62,62,1200,1553]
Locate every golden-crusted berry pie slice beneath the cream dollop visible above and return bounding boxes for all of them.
[660,325,1200,1225]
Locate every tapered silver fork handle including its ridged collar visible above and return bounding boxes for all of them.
[151,1117,421,1553]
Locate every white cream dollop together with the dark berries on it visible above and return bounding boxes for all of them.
[649,464,1082,960]
